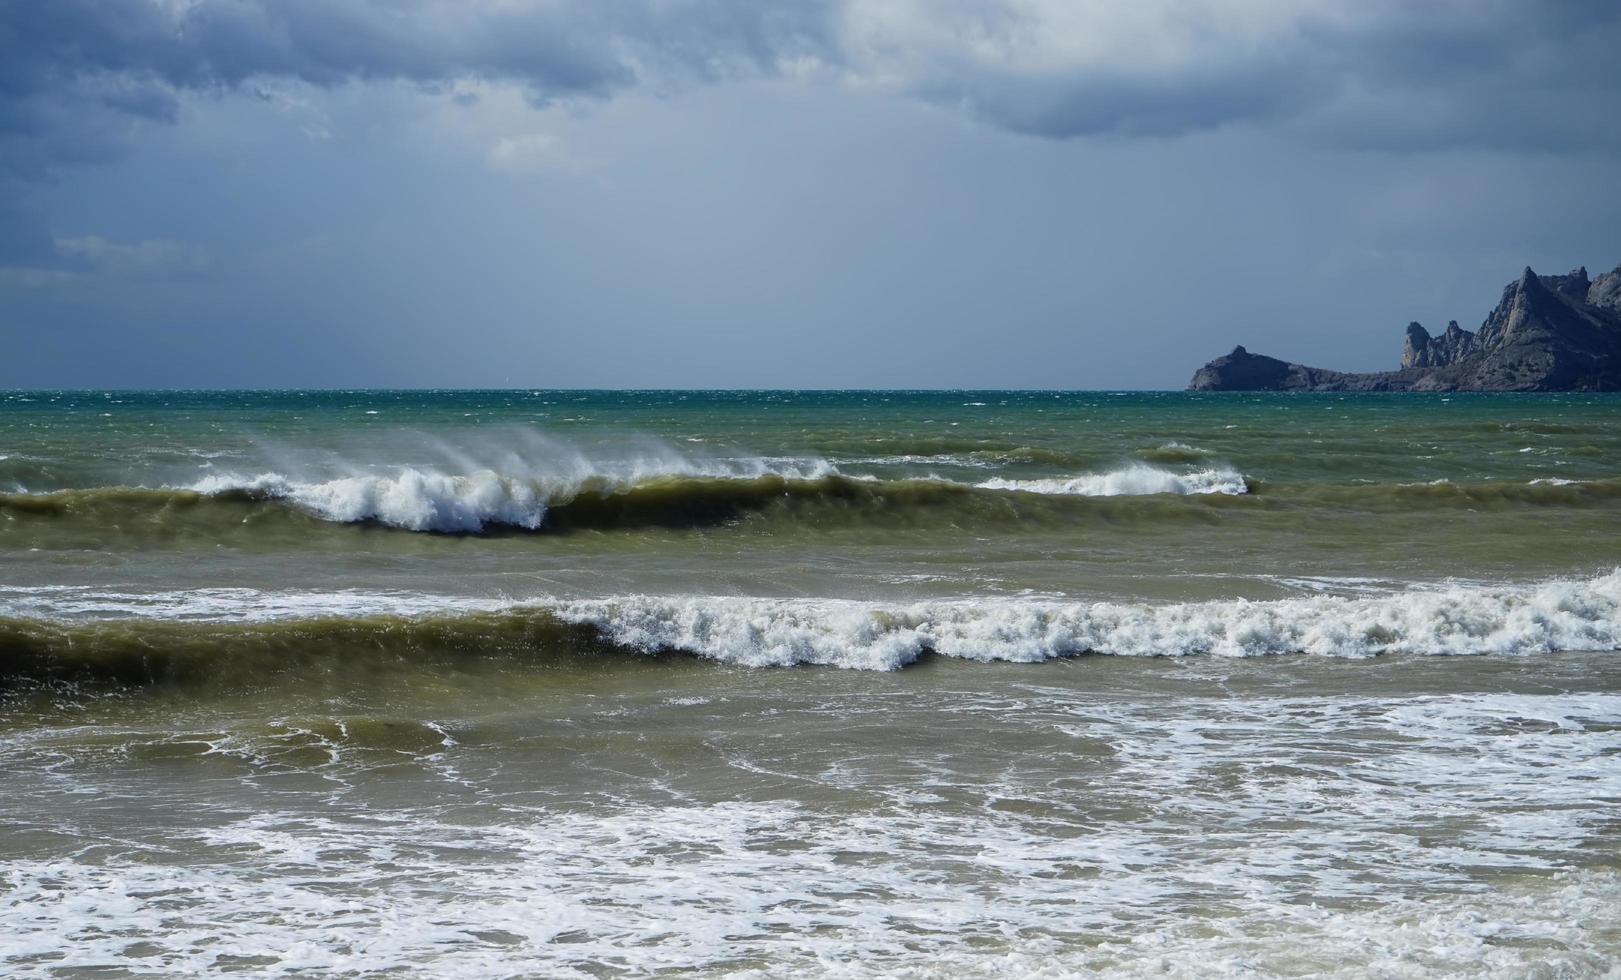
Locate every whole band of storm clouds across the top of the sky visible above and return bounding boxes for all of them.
[0,0,1621,275]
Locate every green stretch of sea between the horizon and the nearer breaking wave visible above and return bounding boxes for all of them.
[9,392,1621,599]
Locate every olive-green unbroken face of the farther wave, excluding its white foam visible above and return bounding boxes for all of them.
[0,475,1621,546]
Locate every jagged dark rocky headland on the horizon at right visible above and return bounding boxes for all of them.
[1188,266,1621,392]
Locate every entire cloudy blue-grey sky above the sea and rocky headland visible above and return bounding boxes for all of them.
[0,0,1621,389]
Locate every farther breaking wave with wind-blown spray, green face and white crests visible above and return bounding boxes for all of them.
[9,462,1621,539]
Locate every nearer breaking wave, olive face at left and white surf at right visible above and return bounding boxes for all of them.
[0,570,1621,682]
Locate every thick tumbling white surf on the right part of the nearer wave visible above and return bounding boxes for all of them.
[546,570,1621,671]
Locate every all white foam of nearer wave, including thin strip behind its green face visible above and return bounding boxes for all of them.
[0,570,1621,671]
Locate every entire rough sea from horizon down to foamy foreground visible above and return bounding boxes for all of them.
[0,390,1621,978]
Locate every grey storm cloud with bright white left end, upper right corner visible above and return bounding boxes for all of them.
[845,0,1621,144]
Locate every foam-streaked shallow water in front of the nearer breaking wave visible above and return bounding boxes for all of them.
[0,685,1621,978]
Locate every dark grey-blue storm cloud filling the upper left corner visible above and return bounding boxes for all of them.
[0,0,828,264]
